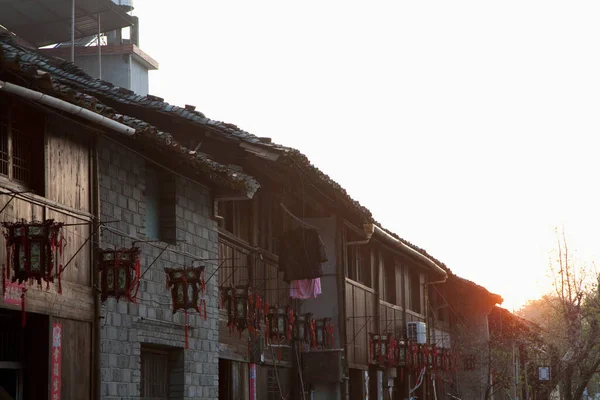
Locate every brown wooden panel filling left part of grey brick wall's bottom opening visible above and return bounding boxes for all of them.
[140,347,169,400]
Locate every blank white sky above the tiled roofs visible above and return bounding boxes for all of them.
[134,0,600,309]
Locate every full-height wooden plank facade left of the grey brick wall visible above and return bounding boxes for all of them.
[0,95,93,399]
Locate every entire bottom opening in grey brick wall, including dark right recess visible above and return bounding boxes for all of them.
[140,344,185,400]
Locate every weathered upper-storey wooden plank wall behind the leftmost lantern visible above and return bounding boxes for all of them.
[0,118,93,320]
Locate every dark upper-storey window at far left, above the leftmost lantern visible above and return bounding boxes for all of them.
[0,101,45,196]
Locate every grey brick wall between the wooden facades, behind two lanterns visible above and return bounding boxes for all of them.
[99,136,219,400]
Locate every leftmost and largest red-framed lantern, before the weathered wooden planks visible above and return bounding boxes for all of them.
[2,219,64,293]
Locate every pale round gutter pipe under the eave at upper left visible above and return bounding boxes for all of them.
[0,81,135,136]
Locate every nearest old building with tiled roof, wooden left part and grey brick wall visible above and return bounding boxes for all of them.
[0,28,258,399]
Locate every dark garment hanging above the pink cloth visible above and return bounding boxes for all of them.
[279,227,327,282]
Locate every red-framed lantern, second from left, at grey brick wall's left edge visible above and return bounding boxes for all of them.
[98,247,140,303]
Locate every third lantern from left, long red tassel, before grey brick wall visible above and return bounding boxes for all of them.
[165,266,207,349]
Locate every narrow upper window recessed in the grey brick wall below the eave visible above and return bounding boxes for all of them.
[145,165,177,244]
